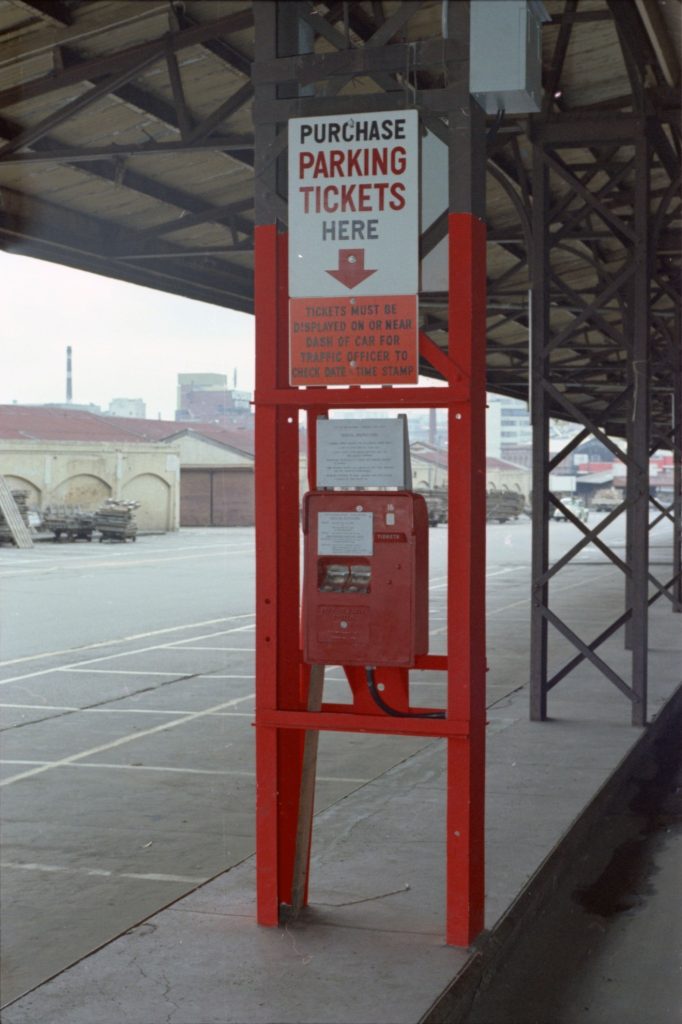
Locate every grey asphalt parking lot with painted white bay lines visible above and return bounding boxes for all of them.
[0,520,663,1004]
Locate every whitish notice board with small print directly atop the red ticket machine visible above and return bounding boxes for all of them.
[316,416,411,488]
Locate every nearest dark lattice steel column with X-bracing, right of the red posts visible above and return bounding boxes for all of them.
[522,112,655,725]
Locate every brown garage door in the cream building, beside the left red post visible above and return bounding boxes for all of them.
[180,469,254,526]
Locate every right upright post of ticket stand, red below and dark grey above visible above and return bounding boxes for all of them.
[445,4,486,945]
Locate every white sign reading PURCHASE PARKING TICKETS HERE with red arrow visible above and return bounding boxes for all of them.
[289,111,419,298]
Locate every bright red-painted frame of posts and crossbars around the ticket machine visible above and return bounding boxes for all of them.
[255,213,485,945]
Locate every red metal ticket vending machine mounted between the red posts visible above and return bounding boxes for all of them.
[303,490,429,668]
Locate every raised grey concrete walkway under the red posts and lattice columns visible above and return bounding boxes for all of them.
[2,600,682,1024]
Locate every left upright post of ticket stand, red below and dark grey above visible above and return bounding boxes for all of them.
[254,0,304,925]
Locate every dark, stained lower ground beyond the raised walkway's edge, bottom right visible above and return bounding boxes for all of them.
[462,720,682,1024]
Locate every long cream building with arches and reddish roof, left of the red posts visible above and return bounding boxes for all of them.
[0,406,254,530]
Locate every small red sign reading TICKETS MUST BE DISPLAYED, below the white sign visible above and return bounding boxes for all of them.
[289,295,419,386]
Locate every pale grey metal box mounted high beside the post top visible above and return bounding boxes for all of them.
[469,0,550,114]
